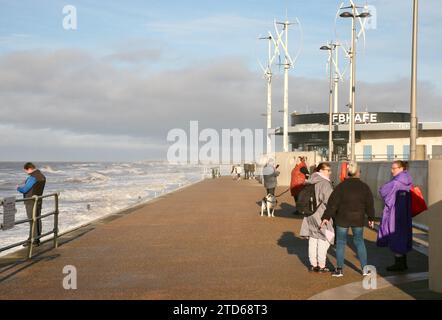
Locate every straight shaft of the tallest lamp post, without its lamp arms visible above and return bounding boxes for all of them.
[350,5,356,161]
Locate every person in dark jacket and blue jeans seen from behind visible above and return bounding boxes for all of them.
[321,162,374,277]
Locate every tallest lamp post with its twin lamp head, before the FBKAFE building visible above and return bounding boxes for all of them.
[340,3,371,161]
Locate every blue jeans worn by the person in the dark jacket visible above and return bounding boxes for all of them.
[336,226,367,270]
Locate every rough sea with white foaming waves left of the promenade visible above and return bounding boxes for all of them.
[0,161,208,255]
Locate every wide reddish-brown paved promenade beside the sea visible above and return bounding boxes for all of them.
[0,178,428,299]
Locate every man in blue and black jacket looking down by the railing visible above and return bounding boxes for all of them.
[17,162,46,245]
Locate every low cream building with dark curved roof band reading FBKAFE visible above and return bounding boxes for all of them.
[275,112,442,161]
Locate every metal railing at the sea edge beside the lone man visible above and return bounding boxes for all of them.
[0,193,60,259]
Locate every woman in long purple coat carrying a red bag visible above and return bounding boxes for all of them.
[377,161,412,271]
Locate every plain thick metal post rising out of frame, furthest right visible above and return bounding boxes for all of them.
[410,0,419,160]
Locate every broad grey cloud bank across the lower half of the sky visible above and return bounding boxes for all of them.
[0,50,442,160]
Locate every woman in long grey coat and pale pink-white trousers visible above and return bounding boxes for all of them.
[300,162,333,273]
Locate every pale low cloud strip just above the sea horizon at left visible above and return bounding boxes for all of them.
[0,125,166,161]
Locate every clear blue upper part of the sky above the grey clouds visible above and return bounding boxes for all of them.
[0,0,442,88]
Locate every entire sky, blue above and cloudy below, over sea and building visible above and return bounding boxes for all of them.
[0,0,442,161]
